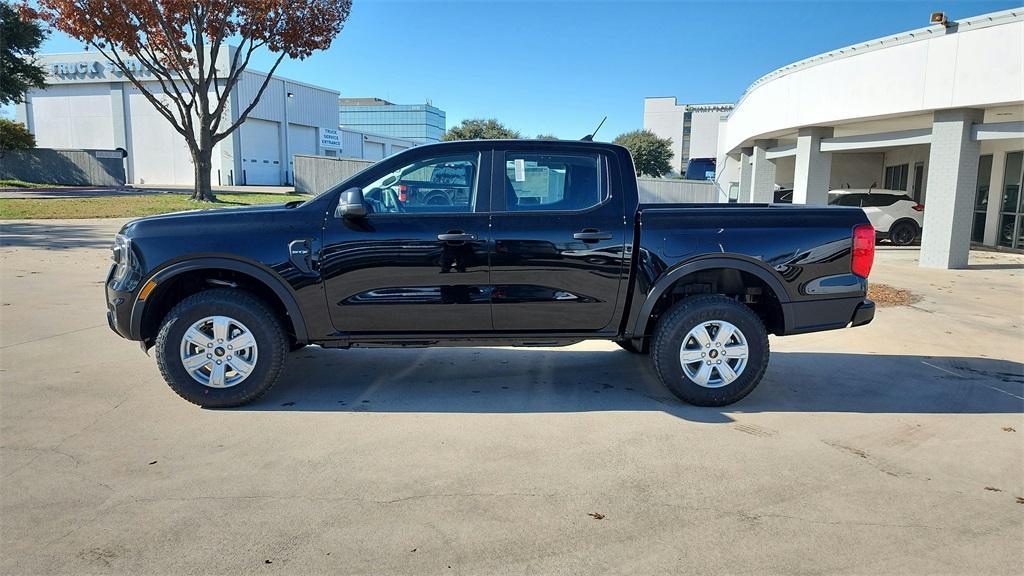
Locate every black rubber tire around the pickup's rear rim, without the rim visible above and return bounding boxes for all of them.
[650,295,769,406]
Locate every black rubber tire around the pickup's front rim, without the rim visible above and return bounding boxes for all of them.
[156,288,289,408]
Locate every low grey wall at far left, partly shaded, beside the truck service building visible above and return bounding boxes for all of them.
[0,148,125,187]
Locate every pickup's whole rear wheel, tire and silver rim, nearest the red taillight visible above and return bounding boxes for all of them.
[650,295,769,406]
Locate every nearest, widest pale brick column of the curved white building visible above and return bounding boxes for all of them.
[920,109,984,269]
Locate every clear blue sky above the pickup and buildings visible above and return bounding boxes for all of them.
[9,0,1020,139]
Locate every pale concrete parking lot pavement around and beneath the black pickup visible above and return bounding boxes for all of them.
[0,220,1024,574]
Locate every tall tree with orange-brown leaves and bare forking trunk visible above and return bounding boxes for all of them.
[20,0,352,201]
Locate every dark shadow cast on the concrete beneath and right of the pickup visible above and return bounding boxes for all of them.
[238,346,1024,422]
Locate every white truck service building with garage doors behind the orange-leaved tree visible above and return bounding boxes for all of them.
[16,48,413,186]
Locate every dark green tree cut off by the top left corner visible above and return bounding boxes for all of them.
[0,2,46,105]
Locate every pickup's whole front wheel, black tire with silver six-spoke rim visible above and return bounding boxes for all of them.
[156,288,289,408]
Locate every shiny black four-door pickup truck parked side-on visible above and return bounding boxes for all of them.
[106,140,874,407]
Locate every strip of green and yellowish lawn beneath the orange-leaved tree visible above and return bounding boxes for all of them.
[0,194,309,219]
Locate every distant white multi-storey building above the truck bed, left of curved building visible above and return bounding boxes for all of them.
[643,96,732,174]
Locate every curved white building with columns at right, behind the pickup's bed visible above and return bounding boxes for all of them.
[718,8,1024,268]
